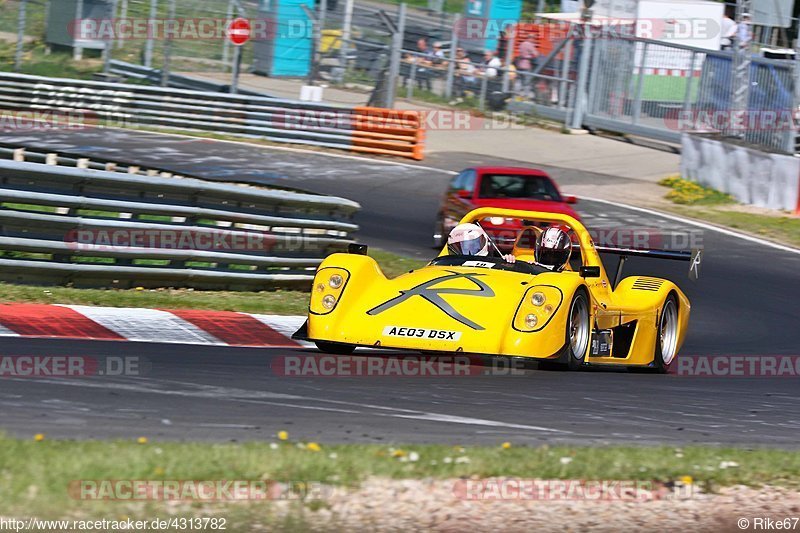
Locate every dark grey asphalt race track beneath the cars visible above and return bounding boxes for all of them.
[0,131,800,447]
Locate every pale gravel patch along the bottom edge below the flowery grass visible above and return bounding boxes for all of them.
[268,479,800,533]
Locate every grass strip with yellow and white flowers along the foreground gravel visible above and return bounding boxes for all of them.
[0,436,800,520]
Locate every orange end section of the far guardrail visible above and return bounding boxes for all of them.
[351,106,425,161]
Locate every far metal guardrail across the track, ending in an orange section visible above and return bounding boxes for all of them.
[0,72,424,159]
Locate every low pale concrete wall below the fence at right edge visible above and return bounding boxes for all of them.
[681,134,800,212]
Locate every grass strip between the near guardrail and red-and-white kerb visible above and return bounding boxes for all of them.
[0,249,425,315]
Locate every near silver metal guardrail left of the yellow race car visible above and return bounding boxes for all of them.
[0,160,359,290]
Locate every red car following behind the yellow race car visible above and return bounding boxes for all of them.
[433,167,580,252]
